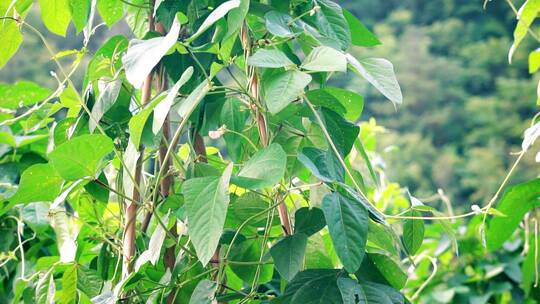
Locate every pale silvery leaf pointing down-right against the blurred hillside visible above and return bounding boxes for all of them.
[346,54,403,104]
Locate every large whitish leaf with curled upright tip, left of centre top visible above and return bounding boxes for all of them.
[122,18,180,89]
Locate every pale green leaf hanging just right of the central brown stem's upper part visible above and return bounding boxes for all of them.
[263,70,311,114]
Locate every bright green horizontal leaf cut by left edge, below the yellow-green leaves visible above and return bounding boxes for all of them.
[0,81,51,110]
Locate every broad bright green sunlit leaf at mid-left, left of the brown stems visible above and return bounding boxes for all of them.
[49,134,114,181]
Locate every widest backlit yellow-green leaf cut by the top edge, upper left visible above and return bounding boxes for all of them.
[38,0,71,36]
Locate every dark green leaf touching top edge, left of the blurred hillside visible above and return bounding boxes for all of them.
[310,0,351,50]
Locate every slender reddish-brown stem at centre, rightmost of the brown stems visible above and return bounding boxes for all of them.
[240,23,292,235]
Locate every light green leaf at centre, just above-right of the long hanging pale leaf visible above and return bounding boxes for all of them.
[233,143,287,189]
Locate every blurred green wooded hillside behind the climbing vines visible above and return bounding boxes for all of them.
[0,0,538,206]
